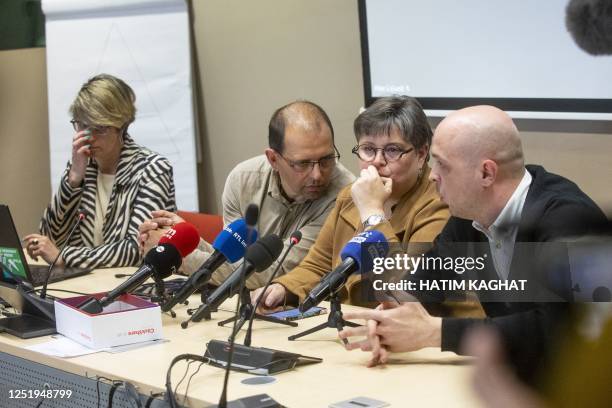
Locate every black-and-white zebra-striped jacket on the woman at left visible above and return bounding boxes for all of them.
[40,134,176,268]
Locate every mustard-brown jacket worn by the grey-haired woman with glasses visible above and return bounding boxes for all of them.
[275,167,449,305]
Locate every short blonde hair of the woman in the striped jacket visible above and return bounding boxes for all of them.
[69,74,136,129]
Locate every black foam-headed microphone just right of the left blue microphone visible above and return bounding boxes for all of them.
[181,234,283,329]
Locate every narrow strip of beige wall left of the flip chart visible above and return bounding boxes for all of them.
[0,48,51,236]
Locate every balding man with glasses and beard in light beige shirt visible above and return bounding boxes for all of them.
[139,101,355,289]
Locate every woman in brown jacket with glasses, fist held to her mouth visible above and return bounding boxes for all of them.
[251,96,449,311]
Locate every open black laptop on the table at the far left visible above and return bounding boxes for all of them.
[0,204,91,286]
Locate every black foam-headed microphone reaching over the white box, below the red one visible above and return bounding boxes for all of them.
[77,243,183,314]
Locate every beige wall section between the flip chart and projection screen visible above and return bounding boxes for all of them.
[193,0,364,210]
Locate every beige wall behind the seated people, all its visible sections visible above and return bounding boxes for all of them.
[0,0,612,233]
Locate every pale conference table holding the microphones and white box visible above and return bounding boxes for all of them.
[0,268,480,407]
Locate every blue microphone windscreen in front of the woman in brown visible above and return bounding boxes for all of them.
[340,230,389,272]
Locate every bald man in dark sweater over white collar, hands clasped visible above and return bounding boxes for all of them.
[340,106,605,378]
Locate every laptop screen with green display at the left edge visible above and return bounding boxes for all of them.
[0,204,30,283]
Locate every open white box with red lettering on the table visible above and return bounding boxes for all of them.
[55,293,162,349]
